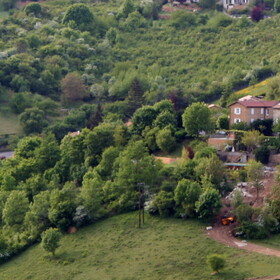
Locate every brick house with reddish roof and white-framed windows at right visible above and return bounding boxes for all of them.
[229,98,280,125]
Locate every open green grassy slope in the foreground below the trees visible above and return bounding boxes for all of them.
[0,213,280,280]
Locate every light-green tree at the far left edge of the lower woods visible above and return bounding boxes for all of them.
[3,191,29,227]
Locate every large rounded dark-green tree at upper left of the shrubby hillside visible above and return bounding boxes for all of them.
[62,4,94,30]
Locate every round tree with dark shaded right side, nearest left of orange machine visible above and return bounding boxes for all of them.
[195,187,222,219]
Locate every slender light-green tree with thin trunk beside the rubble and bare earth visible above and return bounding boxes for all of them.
[246,160,264,200]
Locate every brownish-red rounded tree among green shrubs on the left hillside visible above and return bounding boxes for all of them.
[61,73,87,104]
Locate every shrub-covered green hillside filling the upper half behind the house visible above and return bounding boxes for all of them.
[0,1,280,139]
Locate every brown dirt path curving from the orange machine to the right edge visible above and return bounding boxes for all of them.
[207,224,280,257]
